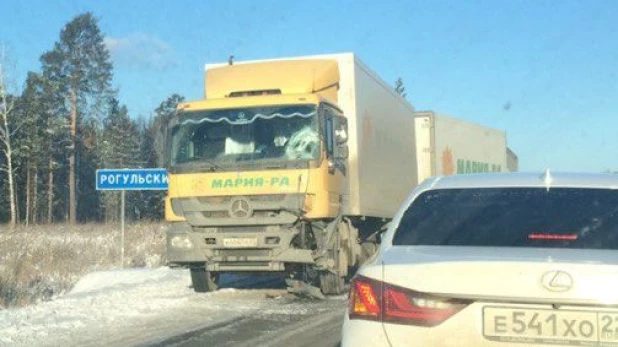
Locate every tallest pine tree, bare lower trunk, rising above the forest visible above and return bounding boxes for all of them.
[41,12,112,224]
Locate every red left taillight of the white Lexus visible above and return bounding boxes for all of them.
[349,276,470,326]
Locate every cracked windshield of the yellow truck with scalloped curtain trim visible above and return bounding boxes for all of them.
[170,105,320,167]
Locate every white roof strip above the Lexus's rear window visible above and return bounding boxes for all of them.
[423,170,618,189]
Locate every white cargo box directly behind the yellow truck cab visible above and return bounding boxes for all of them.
[335,54,418,218]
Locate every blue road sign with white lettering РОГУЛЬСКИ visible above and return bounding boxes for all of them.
[97,168,167,190]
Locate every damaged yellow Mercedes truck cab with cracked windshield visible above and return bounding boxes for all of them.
[165,60,348,291]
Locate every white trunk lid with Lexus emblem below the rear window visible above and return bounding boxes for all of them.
[382,246,618,304]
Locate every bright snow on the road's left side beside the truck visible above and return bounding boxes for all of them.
[0,267,283,346]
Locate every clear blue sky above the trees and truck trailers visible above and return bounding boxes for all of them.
[0,0,618,172]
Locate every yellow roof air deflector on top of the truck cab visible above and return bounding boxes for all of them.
[205,59,339,103]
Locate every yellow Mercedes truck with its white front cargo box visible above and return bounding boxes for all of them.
[165,53,506,294]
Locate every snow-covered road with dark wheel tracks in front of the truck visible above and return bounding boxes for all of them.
[0,267,346,346]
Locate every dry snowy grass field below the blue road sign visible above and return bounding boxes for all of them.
[0,223,166,309]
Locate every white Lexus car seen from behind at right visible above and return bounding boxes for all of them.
[342,171,618,347]
